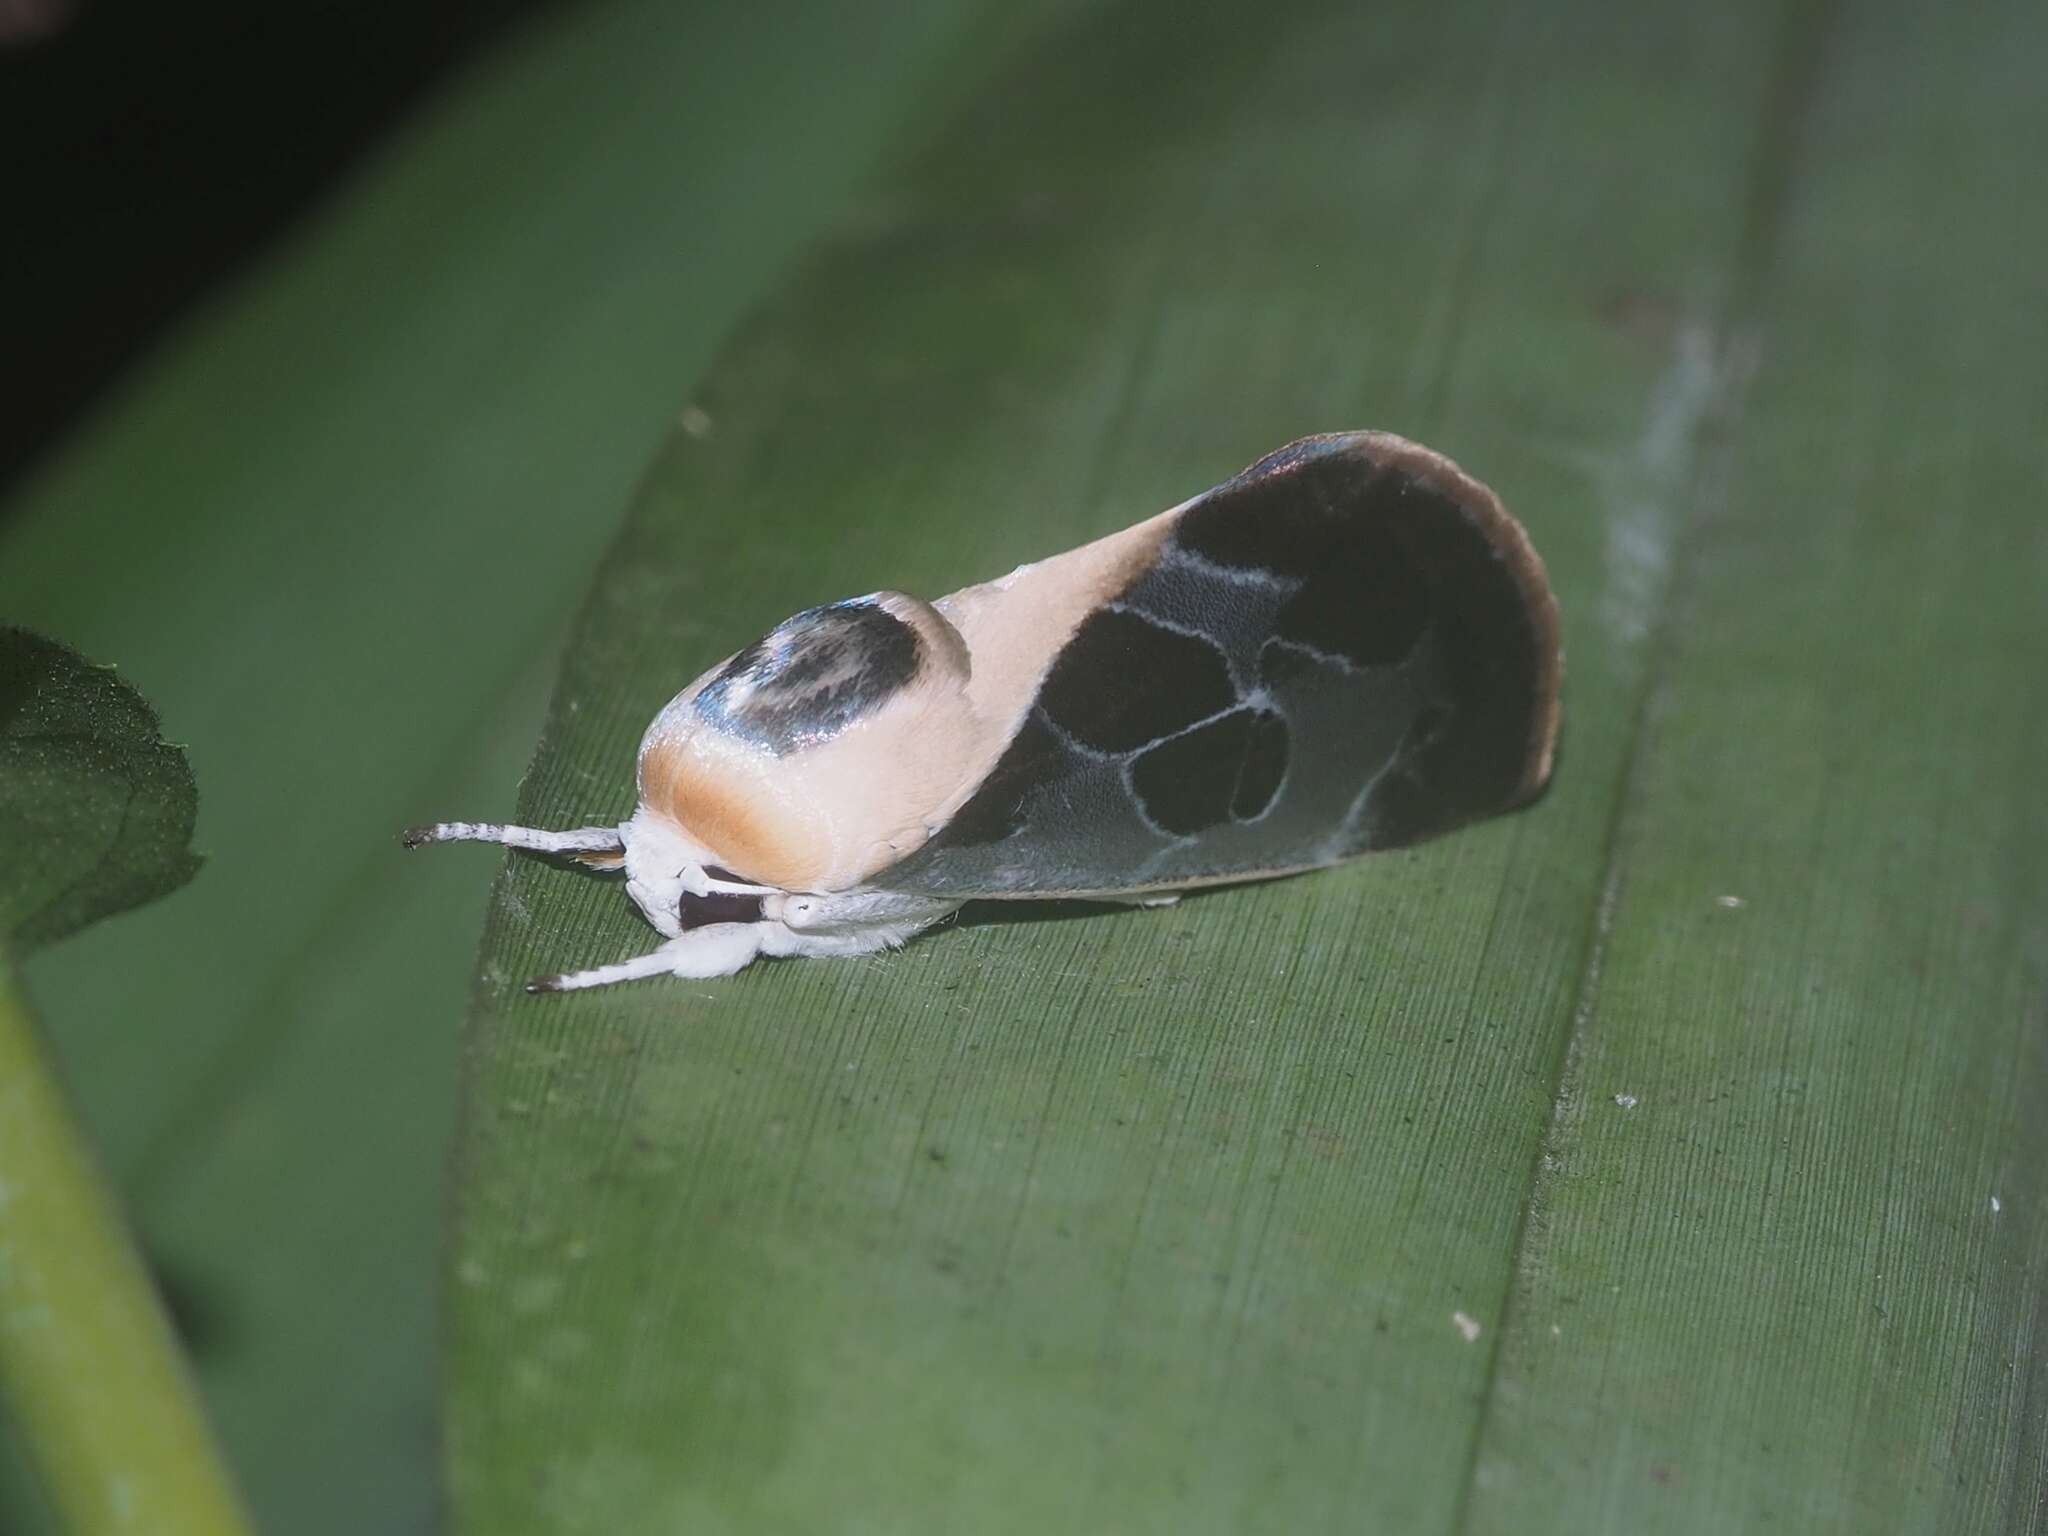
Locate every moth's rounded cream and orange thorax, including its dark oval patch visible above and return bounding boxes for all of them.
[629,592,983,905]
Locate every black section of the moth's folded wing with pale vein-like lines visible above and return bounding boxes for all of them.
[868,432,1561,897]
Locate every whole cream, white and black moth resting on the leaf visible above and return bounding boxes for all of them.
[406,432,1563,991]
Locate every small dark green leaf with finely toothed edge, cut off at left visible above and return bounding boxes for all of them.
[0,627,199,952]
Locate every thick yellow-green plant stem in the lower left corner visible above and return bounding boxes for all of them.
[0,956,250,1536]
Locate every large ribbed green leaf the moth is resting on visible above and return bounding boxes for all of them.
[444,0,2048,1534]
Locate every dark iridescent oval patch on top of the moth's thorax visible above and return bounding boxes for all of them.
[694,598,924,756]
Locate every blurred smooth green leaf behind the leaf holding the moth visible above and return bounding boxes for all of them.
[0,0,1007,1536]
